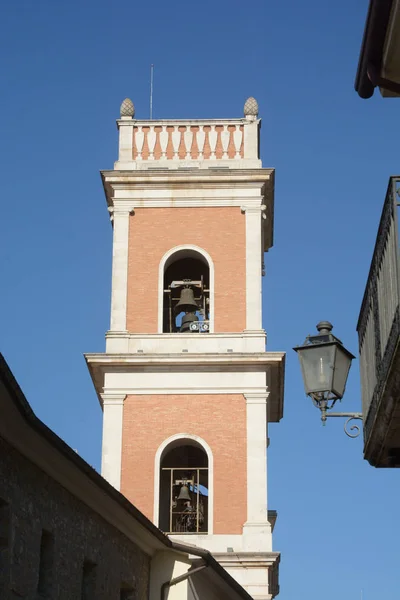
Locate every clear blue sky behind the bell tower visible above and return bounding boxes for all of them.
[0,0,400,600]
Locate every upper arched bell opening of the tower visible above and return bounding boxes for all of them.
[163,250,210,333]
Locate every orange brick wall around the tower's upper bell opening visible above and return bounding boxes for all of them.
[127,206,246,333]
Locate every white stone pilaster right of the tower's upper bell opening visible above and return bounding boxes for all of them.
[242,206,262,331]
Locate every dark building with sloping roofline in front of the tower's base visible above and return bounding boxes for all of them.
[0,355,258,600]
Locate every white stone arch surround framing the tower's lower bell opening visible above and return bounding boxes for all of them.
[153,433,214,541]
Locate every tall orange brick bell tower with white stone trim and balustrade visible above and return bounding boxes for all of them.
[86,98,284,599]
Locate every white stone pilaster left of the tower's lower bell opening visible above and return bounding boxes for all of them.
[101,393,126,490]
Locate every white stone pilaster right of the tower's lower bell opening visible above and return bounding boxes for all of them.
[244,391,269,530]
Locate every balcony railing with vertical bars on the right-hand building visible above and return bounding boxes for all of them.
[357,177,400,458]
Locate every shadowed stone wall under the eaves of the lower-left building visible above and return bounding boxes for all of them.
[0,438,150,600]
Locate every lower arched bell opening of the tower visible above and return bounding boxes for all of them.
[159,440,209,534]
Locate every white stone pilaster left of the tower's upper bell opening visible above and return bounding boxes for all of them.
[110,206,130,331]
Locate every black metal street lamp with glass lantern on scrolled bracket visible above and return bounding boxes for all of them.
[293,321,362,437]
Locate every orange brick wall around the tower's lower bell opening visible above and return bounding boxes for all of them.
[121,394,247,534]
